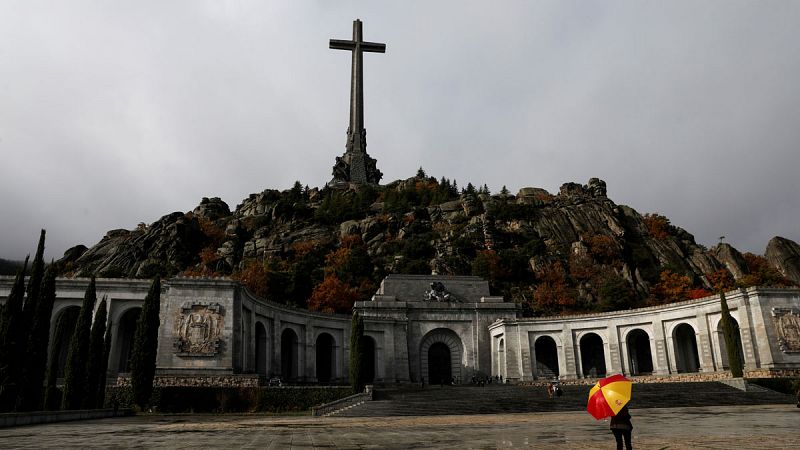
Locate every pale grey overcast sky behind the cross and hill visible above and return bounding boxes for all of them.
[0,0,800,259]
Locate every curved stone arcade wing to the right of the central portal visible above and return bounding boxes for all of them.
[489,288,800,381]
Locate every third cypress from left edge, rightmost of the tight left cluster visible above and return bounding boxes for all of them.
[17,262,56,411]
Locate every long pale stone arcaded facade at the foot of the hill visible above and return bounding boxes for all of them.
[0,275,800,386]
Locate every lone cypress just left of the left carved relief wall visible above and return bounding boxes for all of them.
[131,278,161,409]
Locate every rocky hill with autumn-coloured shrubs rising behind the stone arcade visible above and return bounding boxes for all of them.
[58,172,800,314]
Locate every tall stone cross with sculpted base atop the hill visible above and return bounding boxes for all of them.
[330,19,386,183]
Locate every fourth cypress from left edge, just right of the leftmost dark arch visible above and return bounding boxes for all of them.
[61,277,97,410]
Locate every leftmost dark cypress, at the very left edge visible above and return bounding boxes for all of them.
[0,257,28,412]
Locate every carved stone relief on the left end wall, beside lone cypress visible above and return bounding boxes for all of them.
[173,302,225,357]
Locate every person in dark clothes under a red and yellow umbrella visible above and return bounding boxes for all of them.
[586,374,633,450]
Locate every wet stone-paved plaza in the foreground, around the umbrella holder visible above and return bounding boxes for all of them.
[0,405,800,449]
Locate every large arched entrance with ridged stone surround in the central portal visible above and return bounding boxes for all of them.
[419,328,464,384]
